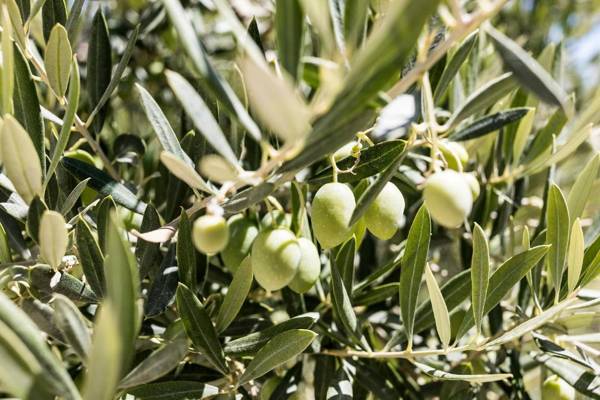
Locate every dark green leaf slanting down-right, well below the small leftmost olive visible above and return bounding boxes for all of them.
[176,283,228,374]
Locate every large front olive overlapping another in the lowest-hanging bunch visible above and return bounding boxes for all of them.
[251,229,302,290]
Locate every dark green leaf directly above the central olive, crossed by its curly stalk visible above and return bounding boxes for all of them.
[308,140,406,185]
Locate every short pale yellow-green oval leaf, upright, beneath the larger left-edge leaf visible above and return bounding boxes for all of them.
[39,210,69,268]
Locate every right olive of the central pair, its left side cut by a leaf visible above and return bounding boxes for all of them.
[365,182,404,240]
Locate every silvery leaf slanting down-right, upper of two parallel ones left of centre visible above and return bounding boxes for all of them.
[165,71,238,166]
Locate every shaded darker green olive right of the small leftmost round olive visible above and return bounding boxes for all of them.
[221,214,258,273]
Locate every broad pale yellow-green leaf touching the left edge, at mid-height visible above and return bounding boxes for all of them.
[0,115,42,203]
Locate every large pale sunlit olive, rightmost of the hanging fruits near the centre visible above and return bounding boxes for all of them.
[423,169,473,228]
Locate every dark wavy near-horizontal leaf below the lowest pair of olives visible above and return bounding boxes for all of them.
[224,313,319,356]
